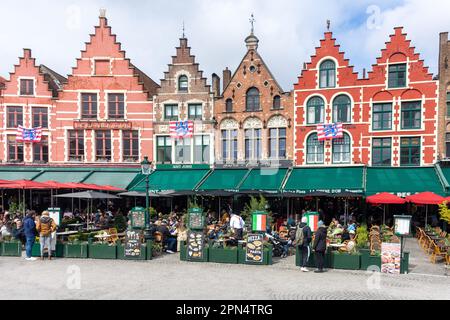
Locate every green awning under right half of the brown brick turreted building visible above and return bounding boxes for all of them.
[239,168,287,193]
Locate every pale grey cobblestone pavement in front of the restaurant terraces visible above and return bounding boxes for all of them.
[0,239,450,300]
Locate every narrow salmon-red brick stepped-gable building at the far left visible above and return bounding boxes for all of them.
[0,49,65,164]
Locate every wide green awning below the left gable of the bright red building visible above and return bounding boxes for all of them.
[283,167,364,195]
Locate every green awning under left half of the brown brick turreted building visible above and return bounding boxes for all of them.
[198,169,249,192]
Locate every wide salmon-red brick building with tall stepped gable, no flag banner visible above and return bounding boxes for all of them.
[50,15,159,165]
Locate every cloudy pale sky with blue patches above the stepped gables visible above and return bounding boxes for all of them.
[0,0,450,91]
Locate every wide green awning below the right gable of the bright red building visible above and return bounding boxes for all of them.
[366,167,445,196]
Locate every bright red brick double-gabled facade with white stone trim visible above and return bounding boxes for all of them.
[294,28,438,167]
